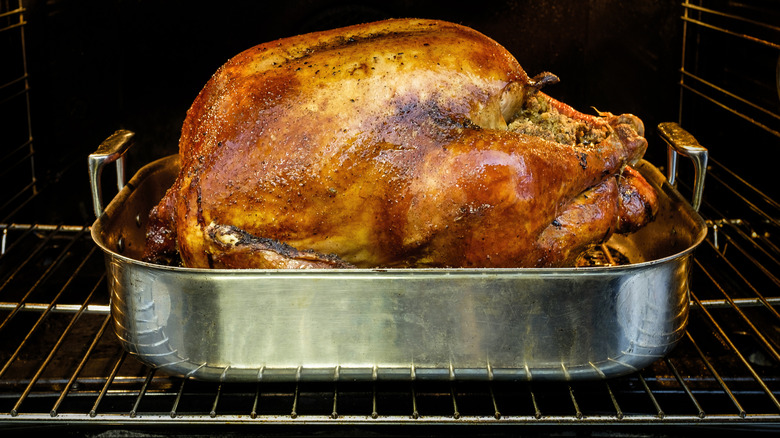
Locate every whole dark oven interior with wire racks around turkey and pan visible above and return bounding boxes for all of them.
[0,0,780,436]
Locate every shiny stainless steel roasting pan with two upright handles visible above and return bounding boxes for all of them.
[89,123,707,382]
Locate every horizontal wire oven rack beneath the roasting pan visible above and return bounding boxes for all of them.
[0,160,780,428]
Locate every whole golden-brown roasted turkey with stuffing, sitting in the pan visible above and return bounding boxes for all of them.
[146,20,654,268]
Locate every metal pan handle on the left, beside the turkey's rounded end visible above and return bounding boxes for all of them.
[87,129,135,217]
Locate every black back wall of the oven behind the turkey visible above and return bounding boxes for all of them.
[27,0,681,222]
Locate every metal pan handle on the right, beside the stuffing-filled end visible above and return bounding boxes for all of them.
[658,122,709,211]
